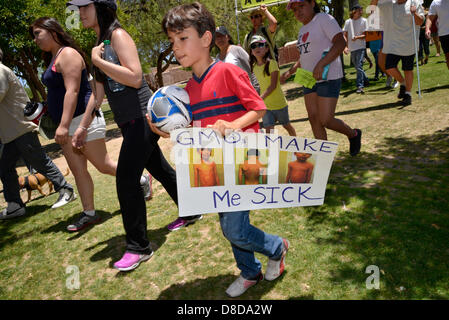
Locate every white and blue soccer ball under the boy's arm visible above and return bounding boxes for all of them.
[147,85,192,132]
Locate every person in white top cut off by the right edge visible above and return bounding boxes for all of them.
[426,0,449,69]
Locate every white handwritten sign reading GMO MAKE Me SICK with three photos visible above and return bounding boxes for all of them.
[171,128,338,217]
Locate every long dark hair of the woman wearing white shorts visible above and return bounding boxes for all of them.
[28,17,89,69]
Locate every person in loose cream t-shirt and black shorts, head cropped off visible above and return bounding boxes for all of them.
[371,0,424,106]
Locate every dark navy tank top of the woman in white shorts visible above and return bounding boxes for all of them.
[42,47,92,124]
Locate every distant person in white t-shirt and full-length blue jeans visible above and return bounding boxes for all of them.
[343,4,368,93]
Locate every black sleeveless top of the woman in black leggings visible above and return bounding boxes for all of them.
[101,71,152,126]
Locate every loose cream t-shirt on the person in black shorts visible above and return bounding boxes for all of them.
[378,0,424,56]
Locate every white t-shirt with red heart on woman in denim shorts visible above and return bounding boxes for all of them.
[297,12,343,80]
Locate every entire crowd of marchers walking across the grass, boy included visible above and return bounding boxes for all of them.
[0,0,449,297]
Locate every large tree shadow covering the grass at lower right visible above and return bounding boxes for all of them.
[306,127,449,299]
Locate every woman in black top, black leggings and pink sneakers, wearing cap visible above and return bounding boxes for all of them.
[68,0,189,271]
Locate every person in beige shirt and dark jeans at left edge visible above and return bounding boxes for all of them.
[0,49,75,220]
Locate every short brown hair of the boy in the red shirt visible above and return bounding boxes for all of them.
[162,2,215,50]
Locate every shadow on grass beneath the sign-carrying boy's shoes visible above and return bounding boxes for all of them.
[157,271,288,300]
